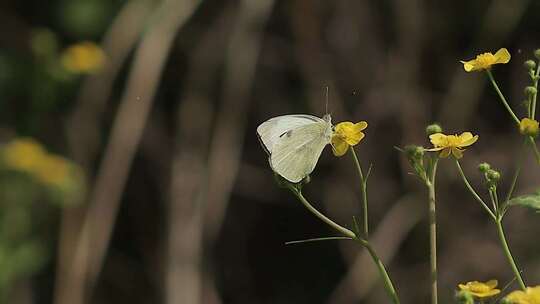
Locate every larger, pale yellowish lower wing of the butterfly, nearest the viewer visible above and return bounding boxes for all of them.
[270,120,332,183]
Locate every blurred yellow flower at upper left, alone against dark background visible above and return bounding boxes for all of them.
[61,41,105,73]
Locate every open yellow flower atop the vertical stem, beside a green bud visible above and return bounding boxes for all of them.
[426,132,478,159]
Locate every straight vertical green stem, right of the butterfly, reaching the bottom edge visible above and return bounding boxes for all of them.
[427,159,438,304]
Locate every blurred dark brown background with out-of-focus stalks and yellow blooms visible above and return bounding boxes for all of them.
[0,0,540,304]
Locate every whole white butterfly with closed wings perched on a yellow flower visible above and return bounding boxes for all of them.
[257,114,333,183]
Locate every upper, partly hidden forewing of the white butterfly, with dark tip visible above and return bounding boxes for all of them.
[257,114,325,154]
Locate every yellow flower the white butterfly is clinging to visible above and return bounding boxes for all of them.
[332,121,367,156]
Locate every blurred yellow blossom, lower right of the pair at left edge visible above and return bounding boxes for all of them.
[34,155,70,186]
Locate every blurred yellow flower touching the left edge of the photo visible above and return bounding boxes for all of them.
[3,138,46,172]
